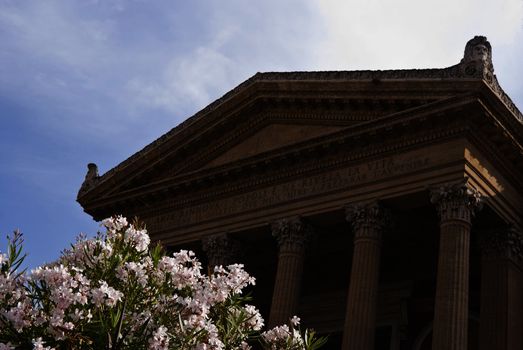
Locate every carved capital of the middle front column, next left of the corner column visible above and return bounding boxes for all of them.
[345,201,392,238]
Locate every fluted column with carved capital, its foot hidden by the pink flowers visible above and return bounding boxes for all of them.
[269,217,312,327]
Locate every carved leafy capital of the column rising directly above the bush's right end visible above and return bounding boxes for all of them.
[271,216,314,251]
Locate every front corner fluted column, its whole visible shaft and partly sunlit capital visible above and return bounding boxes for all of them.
[431,182,480,350]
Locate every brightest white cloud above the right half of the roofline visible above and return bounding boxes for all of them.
[316,0,523,70]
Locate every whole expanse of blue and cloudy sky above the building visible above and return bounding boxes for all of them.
[0,0,523,267]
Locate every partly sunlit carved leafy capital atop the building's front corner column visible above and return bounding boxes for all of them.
[430,179,482,223]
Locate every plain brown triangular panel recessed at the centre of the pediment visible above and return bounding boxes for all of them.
[202,124,343,168]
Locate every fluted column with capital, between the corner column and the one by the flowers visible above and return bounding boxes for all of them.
[342,202,390,350]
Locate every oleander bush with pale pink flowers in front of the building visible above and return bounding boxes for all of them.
[0,216,322,350]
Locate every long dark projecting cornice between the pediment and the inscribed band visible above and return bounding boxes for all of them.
[78,94,515,219]
